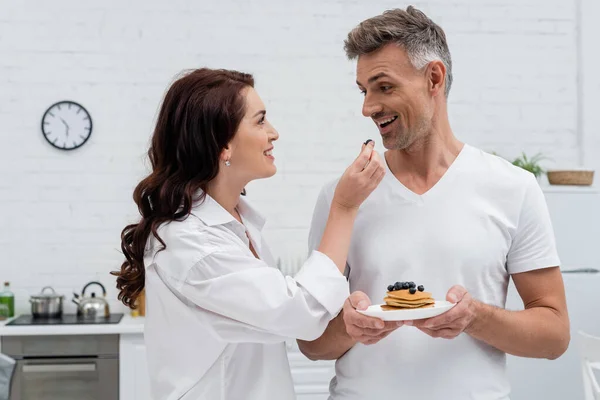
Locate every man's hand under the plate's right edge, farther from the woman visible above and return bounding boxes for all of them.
[406,285,476,339]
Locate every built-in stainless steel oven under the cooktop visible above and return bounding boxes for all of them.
[2,335,119,400]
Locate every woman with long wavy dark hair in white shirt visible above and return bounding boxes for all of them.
[113,69,384,400]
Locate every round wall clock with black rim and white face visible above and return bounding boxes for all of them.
[42,101,92,150]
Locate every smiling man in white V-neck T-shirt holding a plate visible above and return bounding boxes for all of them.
[299,7,570,400]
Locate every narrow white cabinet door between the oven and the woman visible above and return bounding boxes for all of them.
[119,333,150,400]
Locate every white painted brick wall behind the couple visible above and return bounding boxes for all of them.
[0,0,600,312]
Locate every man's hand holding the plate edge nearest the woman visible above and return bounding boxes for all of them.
[342,292,403,345]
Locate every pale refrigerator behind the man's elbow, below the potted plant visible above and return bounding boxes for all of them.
[506,186,600,400]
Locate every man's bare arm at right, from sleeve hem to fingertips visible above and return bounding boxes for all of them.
[413,267,570,360]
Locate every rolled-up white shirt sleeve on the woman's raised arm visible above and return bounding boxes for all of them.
[178,246,349,343]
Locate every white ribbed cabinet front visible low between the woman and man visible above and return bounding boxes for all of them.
[286,340,335,400]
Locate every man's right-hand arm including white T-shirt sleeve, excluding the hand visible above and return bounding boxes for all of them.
[452,174,570,359]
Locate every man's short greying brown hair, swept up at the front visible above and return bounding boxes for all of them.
[344,6,452,98]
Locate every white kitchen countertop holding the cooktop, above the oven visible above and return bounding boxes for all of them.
[0,314,144,336]
